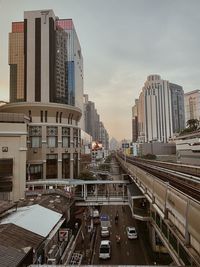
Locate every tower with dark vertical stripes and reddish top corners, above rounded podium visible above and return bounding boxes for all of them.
[9,10,83,110]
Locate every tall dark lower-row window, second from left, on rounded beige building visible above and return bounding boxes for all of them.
[46,154,58,179]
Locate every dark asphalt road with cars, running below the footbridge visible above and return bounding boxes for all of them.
[92,206,149,265]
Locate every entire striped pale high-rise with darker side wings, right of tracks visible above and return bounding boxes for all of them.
[132,75,185,143]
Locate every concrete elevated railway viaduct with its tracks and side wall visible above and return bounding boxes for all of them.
[116,154,200,266]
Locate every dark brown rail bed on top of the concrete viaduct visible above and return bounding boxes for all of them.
[120,157,200,201]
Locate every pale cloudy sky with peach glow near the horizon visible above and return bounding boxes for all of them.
[0,0,200,140]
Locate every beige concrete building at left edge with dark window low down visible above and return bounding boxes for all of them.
[0,113,29,201]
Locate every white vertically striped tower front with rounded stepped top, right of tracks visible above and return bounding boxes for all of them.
[143,75,172,142]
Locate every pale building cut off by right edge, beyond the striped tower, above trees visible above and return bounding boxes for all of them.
[184,89,200,123]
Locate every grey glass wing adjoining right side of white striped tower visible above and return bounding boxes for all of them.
[169,83,185,133]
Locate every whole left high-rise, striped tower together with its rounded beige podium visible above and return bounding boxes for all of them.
[0,10,83,200]
